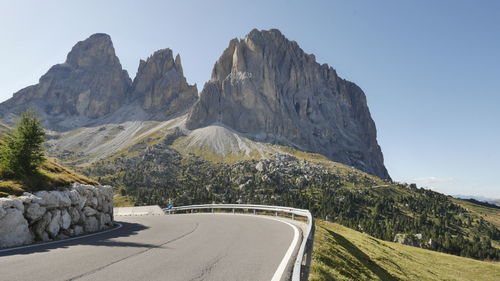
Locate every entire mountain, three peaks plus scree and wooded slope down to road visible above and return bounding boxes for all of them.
[0,30,500,260]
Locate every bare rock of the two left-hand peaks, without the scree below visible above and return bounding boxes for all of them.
[0,33,198,133]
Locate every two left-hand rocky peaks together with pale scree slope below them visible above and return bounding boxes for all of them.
[0,33,198,166]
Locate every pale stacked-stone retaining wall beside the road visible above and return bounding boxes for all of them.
[0,183,113,248]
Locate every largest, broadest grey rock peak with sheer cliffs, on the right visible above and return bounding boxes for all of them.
[186,30,389,178]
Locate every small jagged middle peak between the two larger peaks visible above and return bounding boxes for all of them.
[132,49,198,115]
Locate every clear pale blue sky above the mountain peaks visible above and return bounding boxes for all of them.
[0,0,500,198]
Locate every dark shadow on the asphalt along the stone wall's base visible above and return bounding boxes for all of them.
[0,222,154,257]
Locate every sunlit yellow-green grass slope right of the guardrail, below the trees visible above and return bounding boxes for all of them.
[309,220,500,281]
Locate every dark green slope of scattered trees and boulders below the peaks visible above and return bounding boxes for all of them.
[83,137,500,260]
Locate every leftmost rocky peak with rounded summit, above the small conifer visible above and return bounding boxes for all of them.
[0,34,132,128]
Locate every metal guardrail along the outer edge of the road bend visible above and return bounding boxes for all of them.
[163,204,314,281]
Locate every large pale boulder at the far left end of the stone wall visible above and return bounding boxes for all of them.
[0,198,33,248]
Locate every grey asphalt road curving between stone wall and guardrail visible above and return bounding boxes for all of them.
[0,214,300,281]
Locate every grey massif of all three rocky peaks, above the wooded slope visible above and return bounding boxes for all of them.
[0,29,390,179]
